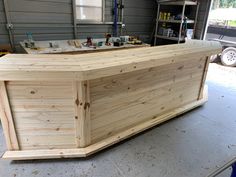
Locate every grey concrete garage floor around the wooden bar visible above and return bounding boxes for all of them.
[0,64,236,177]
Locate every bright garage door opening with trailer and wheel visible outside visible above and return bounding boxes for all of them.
[205,0,236,66]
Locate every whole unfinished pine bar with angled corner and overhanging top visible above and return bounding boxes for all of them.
[0,40,221,160]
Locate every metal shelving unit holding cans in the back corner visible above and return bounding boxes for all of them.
[154,1,199,45]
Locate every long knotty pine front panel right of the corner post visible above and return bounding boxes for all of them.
[90,58,206,143]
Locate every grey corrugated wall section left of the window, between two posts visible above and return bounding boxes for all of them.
[8,0,73,43]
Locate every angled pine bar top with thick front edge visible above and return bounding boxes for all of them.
[0,40,222,80]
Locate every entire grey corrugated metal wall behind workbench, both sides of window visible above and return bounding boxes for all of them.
[0,0,210,44]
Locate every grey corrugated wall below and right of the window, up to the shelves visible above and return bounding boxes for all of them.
[78,0,156,42]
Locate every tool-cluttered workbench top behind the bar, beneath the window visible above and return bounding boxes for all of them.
[20,38,150,54]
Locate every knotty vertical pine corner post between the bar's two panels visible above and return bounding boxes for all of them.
[73,81,91,148]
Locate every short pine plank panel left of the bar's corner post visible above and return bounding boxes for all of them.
[7,81,76,150]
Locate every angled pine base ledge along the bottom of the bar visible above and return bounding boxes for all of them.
[2,86,208,160]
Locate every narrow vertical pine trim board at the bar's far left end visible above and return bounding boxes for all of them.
[0,81,19,150]
